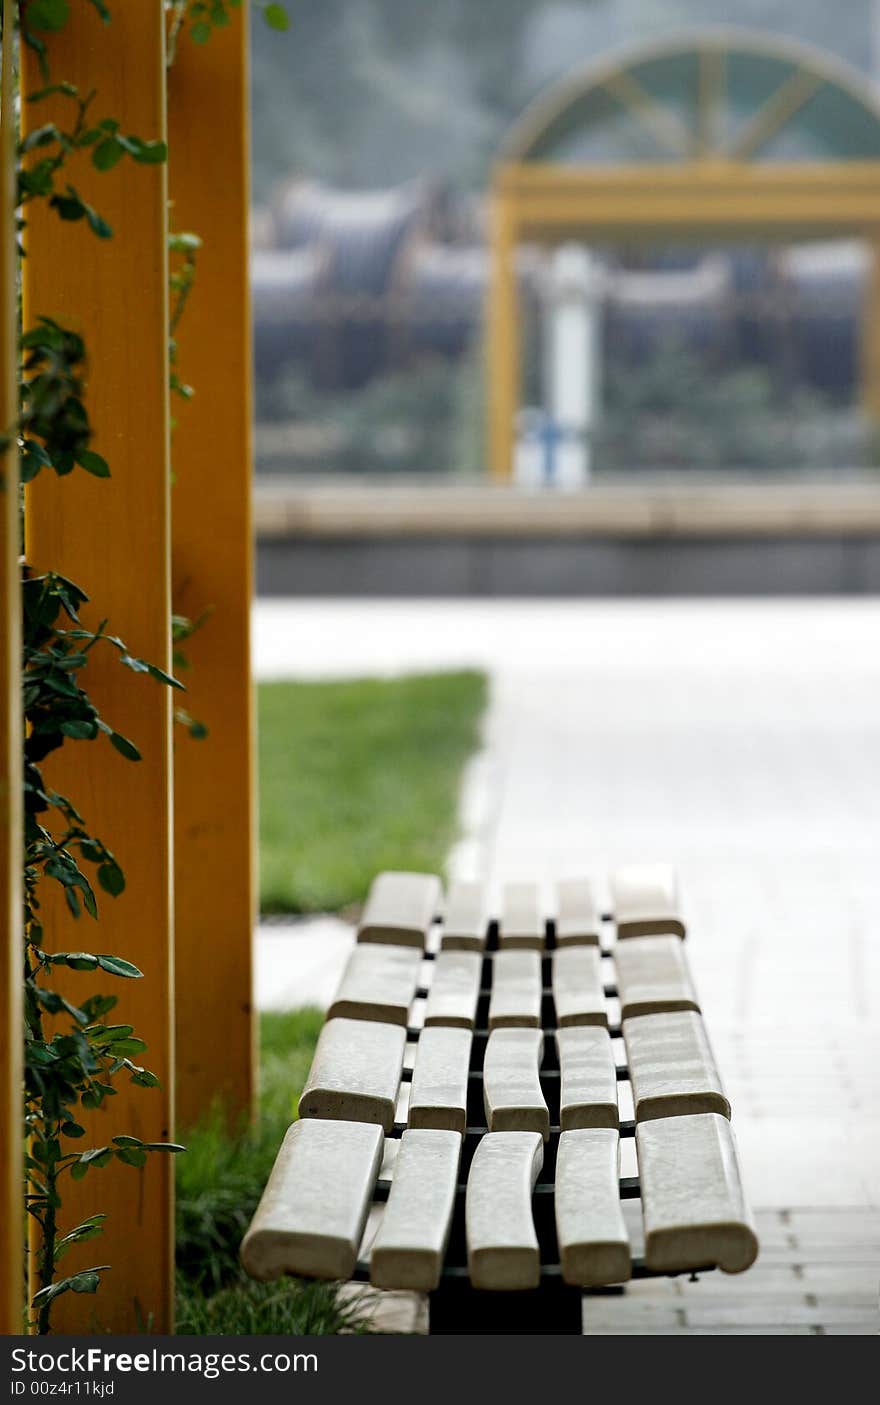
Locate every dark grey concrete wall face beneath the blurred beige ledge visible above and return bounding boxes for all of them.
[257,531,880,596]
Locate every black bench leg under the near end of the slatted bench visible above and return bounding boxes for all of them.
[427,1279,583,1336]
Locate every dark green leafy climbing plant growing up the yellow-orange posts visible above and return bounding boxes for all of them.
[9,0,287,1333]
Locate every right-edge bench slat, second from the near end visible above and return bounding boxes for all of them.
[623,1010,730,1123]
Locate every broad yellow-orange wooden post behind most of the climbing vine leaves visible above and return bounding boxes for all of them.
[24,0,175,1332]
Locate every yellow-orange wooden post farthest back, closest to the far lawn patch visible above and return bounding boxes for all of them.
[169,7,256,1128]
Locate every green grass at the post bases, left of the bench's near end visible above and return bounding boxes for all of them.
[176,1010,351,1336]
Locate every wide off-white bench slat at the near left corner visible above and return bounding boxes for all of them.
[240,1121,384,1281]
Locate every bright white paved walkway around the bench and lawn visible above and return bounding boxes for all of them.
[256,600,880,1333]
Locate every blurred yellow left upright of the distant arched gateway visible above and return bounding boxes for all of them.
[485,190,520,482]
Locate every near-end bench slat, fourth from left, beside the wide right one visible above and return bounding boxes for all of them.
[554,1127,633,1288]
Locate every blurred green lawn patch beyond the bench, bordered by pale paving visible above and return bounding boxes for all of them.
[259,672,486,912]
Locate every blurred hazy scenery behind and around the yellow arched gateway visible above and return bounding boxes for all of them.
[253,0,880,511]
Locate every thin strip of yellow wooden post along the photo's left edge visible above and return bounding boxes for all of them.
[0,0,24,1333]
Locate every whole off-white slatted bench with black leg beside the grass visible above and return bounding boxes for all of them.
[242,865,758,1335]
